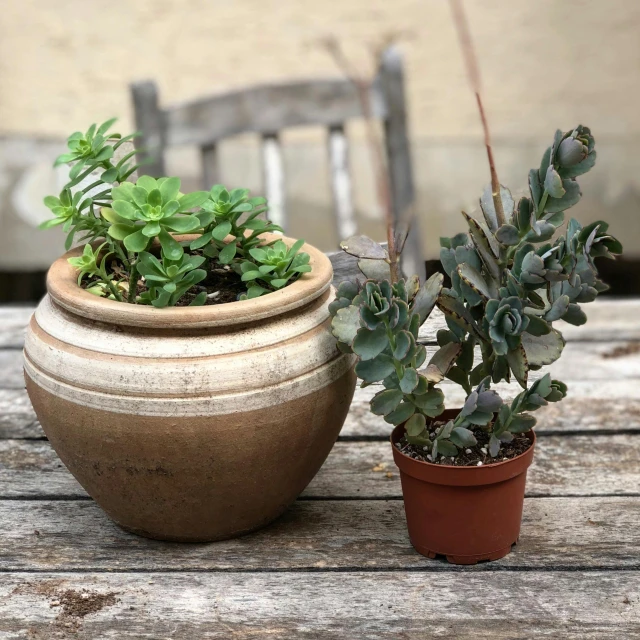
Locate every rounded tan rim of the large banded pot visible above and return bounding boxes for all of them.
[47,233,333,329]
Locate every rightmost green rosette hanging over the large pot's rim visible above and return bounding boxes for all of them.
[238,240,311,298]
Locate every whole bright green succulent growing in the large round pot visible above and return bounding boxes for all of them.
[41,119,311,307]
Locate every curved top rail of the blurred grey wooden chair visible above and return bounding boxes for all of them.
[166,78,386,146]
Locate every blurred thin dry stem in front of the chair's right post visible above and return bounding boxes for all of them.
[322,37,400,282]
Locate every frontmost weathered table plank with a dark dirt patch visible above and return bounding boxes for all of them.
[0,571,640,640]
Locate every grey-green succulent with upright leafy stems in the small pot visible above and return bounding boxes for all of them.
[330,126,622,461]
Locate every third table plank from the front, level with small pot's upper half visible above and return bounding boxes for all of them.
[0,434,640,499]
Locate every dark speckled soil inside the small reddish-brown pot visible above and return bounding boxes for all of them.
[396,422,531,467]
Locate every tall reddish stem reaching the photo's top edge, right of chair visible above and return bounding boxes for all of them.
[449,0,505,226]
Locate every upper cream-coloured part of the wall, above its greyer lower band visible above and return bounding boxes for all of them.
[0,0,640,138]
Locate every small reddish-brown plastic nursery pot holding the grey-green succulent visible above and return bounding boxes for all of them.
[391,409,535,564]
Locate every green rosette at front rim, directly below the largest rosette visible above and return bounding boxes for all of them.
[138,251,207,308]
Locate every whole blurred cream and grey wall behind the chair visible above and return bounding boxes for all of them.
[0,0,640,268]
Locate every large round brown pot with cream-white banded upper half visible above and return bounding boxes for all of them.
[24,236,356,541]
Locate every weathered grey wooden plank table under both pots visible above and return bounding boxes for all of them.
[0,262,640,640]
